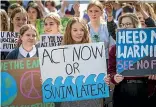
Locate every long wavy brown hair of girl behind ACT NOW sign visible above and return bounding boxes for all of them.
[63,17,90,45]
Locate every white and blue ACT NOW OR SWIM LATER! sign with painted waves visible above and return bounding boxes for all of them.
[39,43,109,102]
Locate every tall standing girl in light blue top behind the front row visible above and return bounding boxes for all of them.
[87,1,115,59]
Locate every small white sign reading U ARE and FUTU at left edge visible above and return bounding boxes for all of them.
[0,32,18,52]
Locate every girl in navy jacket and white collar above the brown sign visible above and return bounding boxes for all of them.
[6,24,38,59]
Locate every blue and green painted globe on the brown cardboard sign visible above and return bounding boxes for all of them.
[1,72,18,106]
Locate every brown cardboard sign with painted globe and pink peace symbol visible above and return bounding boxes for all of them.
[1,58,55,107]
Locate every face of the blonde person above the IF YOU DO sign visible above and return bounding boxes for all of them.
[44,18,59,34]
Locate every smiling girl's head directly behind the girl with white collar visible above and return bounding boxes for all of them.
[10,7,28,32]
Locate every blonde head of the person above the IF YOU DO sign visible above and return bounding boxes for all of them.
[43,13,61,34]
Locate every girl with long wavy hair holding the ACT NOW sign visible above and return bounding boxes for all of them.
[61,17,109,107]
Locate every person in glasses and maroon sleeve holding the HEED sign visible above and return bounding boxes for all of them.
[108,13,156,107]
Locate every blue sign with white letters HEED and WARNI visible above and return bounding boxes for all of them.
[116,28,156,76]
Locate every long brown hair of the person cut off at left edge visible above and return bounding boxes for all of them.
[0,9,10,31]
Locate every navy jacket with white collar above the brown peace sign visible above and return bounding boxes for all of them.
[6,45,38,60]
